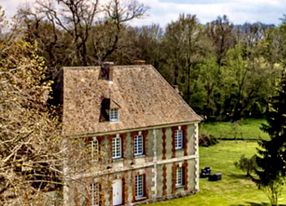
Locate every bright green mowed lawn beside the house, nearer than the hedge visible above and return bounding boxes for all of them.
[151,141,286,206]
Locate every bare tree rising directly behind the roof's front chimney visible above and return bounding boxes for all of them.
[91,0,148,64]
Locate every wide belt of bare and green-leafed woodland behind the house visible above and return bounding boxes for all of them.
[9,0,286,121]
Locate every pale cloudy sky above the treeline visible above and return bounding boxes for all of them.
[0,0,286,27]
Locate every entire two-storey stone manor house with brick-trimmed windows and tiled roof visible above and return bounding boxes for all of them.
[62,63,201,206]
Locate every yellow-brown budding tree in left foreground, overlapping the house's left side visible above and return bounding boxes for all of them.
[0,37,62,205]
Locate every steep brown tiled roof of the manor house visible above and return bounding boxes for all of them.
[63,65,201,135]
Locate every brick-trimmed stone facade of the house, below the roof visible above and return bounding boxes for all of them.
[66,123,199,206]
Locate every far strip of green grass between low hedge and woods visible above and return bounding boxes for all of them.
[200,119,268,140]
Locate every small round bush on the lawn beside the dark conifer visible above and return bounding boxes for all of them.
[234,155,256,177]
